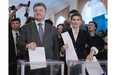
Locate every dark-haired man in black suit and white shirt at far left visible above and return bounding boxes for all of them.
[9,18,20,75]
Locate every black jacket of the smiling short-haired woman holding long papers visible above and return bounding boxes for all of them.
[63,29,95,59]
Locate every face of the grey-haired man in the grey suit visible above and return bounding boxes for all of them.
[34,6,46,21]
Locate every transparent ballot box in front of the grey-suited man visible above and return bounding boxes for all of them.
[18,60,64,75]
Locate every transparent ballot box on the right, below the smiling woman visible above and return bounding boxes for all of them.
[67,60,107,75]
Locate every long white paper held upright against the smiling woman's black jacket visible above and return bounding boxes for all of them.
[61,32,78,63]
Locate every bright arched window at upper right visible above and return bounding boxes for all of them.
[82,0,106,24]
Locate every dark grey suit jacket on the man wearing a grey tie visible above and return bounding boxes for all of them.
[17,22,59,59]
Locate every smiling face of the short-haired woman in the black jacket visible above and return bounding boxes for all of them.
[71,16,82,28]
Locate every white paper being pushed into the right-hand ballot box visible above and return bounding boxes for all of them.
[85,56,104,75]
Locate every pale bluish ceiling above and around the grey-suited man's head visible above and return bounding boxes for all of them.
[9,0,69,24]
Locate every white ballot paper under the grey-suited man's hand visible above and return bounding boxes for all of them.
[28,47,47,70]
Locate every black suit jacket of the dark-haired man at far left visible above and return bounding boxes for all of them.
[8,31,17,75]
